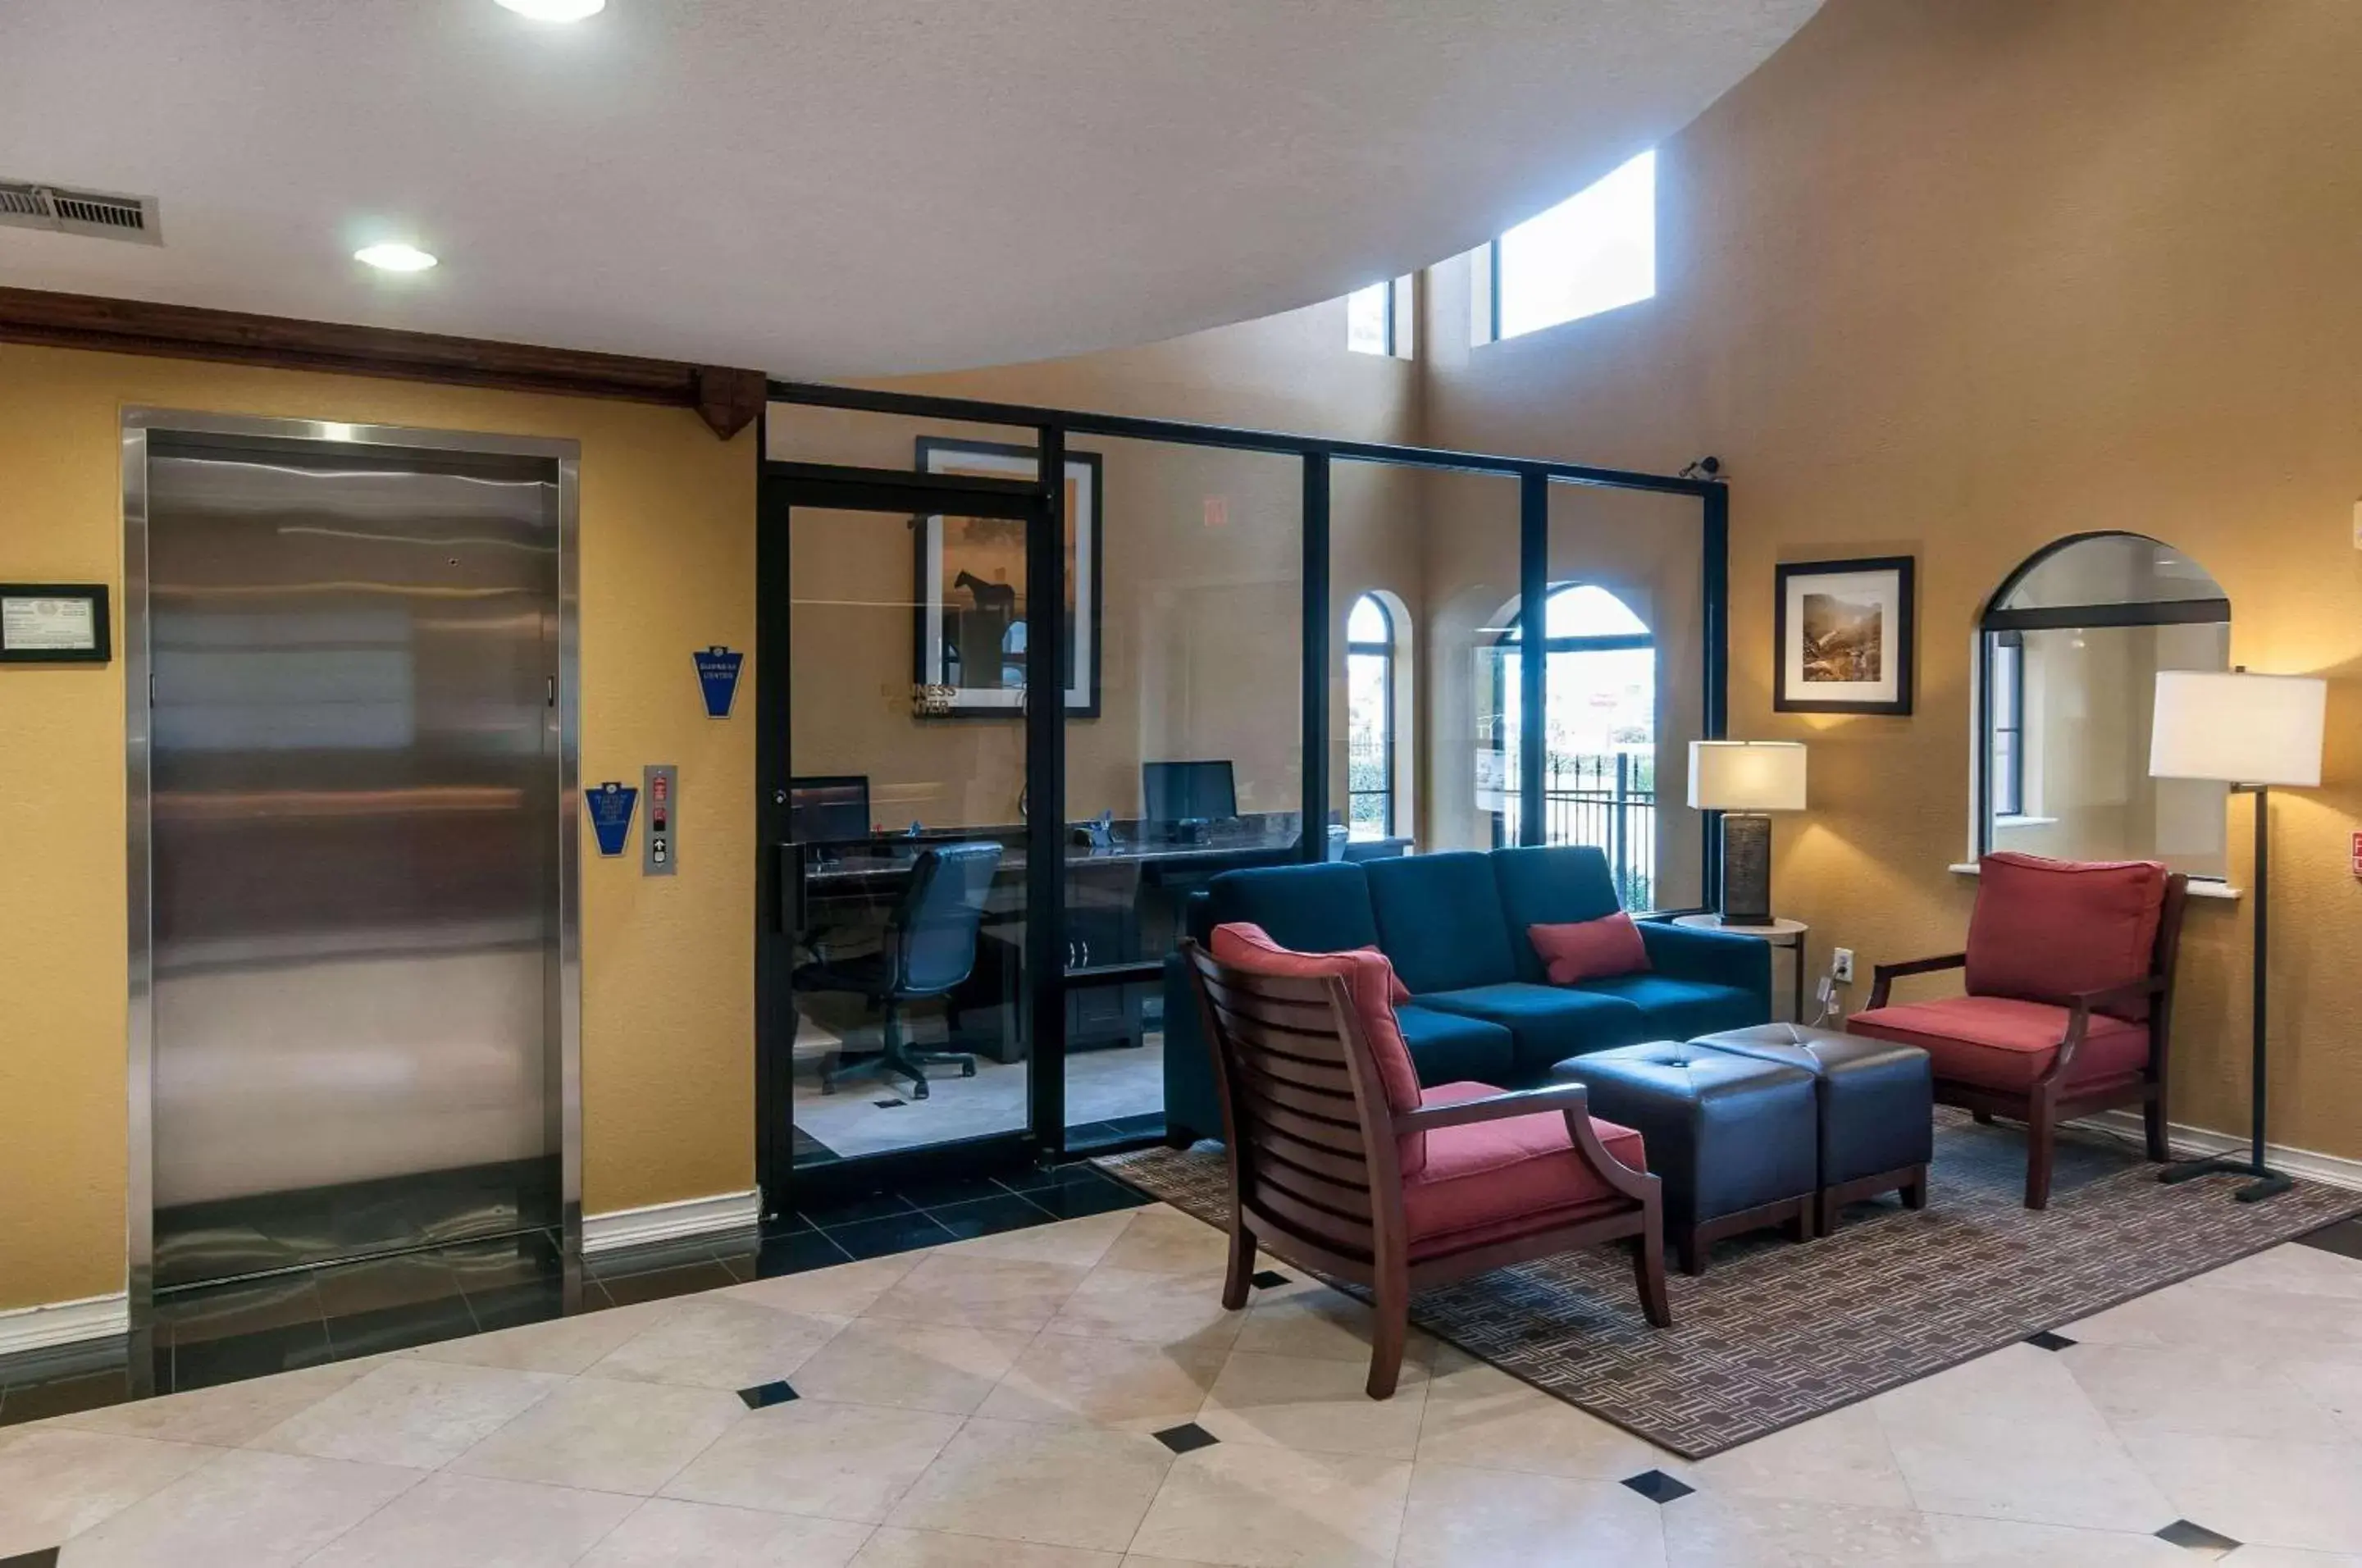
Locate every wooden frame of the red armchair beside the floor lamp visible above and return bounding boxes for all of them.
[1868,872,2190,1209]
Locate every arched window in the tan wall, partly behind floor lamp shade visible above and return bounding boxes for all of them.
[1977,534,2230,876]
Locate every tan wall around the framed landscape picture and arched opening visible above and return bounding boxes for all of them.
[1425,0,2362,1157]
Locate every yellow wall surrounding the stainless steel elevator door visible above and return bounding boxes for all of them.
[0,344,754,1308]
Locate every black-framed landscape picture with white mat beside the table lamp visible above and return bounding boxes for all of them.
[1772,555,1918,715]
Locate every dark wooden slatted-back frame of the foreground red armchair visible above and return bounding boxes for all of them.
[1181,942,1672,1401]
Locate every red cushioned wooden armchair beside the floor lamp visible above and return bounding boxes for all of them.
[1847,855,2190,1209]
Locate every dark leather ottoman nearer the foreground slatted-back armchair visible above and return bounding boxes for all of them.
[1549,1039,1819,1275]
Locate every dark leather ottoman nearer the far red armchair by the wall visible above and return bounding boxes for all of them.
[1694,1023,1935,1235]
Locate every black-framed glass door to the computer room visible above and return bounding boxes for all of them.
[756,463,1058,1211]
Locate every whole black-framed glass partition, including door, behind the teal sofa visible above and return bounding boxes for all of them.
[754,382,1724,1211]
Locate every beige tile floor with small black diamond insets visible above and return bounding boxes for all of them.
[0,1206,2362,1568]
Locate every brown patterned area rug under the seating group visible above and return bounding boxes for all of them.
[1098,1110,2362,1460]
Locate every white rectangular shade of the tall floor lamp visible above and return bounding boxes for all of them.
[2150,671,2329,789]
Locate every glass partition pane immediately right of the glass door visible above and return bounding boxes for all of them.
[1063,435,1304,1150]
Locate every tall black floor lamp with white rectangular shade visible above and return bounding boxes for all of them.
[2150,668,2329,1205]
